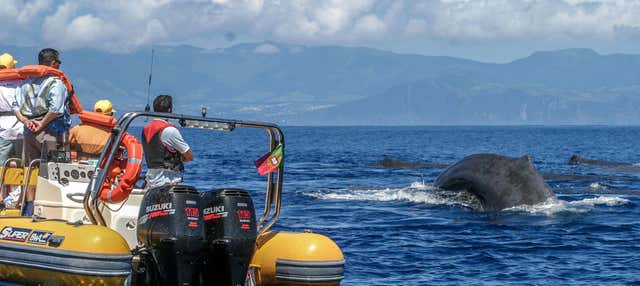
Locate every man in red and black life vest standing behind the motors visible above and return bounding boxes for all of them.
[142,95,193,189]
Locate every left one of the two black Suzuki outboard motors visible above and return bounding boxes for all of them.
[137,185,205,286]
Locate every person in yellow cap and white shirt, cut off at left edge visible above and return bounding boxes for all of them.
[0,53,24,208]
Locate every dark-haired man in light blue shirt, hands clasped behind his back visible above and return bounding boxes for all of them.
[13,48,71,216]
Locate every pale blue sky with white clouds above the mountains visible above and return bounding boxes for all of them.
[0,0,640,62]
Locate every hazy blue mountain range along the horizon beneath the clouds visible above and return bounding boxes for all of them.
[1,42,640,125]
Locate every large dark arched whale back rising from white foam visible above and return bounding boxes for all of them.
[435,154,555,212]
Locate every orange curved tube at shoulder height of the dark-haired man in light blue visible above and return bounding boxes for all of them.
[0,65,82,114]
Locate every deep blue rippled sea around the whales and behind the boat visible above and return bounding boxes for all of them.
[184,126,640,285]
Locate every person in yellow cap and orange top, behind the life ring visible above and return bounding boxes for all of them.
[69,99,116,160]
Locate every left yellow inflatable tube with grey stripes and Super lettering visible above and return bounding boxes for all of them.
[0,217,131,285]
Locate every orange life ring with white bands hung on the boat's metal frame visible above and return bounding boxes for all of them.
[98,133,143,203]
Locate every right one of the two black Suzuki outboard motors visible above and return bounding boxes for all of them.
[201,189,257,286]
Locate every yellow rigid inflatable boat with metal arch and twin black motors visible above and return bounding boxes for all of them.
[0,67,345,286]
